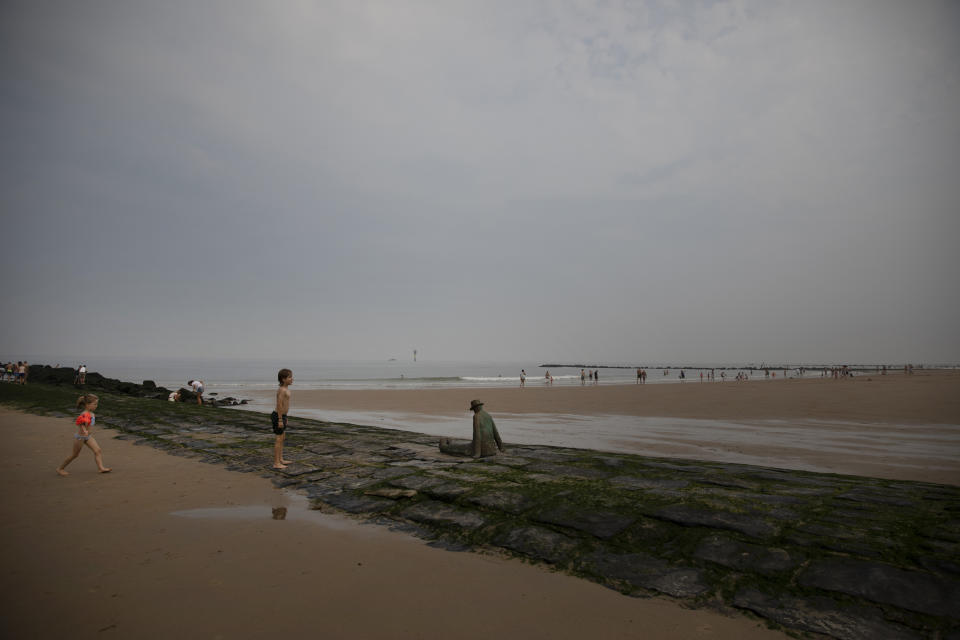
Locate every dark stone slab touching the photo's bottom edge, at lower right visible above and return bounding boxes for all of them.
[733,589,921,640]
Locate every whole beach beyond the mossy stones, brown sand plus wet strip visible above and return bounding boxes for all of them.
[253,371,960,485]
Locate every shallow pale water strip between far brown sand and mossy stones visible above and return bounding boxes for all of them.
[231,401,960,484]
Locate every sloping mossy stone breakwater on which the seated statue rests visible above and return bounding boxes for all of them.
[7,385,960,640]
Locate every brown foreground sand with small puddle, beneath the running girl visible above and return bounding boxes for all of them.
[0,403,786,640]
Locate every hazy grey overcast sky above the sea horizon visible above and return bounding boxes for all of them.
[0,0,960,362]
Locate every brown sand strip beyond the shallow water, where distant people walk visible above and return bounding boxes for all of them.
[270,371,960,425]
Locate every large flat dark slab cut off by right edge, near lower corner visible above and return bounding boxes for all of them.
[798,558,960,619]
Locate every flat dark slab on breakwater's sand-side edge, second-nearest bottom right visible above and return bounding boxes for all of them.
[582,552,710,598]
